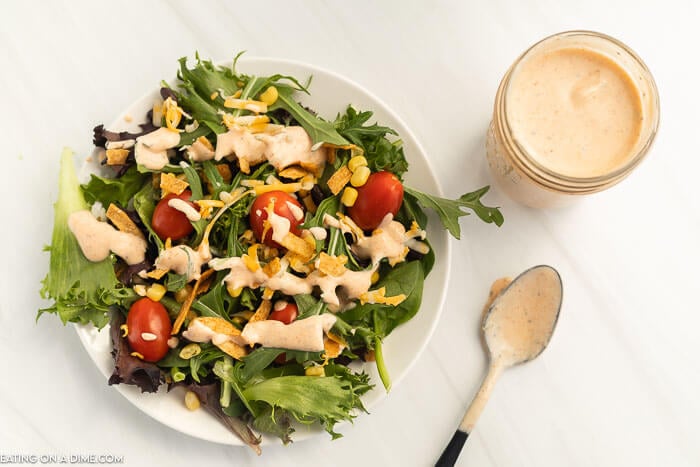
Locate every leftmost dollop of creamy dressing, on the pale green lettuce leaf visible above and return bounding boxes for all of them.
[68,210,148,265]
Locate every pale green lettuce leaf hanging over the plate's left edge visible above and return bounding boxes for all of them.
[37,149,133,328]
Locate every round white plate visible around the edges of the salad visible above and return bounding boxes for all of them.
[76,58,450,445]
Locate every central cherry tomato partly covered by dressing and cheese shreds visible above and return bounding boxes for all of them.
[250,191,304,248]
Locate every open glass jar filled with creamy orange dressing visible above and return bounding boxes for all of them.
[486,31,659,208]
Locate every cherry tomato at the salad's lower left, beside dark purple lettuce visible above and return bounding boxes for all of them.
[126,297,172,362]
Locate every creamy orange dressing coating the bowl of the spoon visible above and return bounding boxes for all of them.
[483,267,562,365]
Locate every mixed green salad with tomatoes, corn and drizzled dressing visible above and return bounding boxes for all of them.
[39,57,503,453]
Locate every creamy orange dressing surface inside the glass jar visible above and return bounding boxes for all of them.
[506,46,643,177]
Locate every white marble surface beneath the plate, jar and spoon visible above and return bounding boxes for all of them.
[0,0,700,466]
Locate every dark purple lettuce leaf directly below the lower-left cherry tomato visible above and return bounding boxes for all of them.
[109,311,163,392]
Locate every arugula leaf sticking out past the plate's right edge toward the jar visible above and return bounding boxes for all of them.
[404,186,503,240]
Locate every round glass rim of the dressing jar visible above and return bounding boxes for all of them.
[496,30,660,193]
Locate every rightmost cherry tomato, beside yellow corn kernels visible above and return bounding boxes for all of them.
[348,172,403,230]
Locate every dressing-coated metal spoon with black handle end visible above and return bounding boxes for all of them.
[435,266,562,467]
